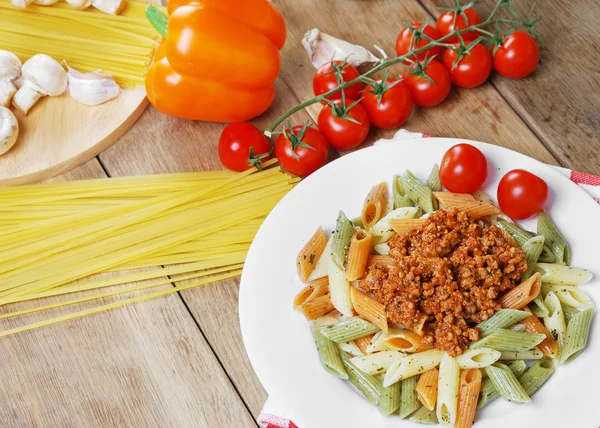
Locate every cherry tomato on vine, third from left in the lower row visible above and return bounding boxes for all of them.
[318,100,371,150]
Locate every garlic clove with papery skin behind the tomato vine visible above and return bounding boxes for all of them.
[302,28,380,68]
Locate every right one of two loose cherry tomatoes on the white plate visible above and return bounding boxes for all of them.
[498,169,548,220]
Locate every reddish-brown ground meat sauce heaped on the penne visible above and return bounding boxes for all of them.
[359,209,527,356]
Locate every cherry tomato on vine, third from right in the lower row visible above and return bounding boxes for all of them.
[402,61,451,107]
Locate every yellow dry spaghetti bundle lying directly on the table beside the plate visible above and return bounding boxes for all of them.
[0,163,298,336]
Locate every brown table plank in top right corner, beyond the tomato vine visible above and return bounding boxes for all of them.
[422,0,600,174]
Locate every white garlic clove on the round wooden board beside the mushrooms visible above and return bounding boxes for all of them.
[67,67,121,106]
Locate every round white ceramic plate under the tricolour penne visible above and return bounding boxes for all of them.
[240,138,600,428]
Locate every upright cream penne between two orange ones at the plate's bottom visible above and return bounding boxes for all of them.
[436,353,460,427]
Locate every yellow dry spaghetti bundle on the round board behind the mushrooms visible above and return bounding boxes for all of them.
[0,0,160,88]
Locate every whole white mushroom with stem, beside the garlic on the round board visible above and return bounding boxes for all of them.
[13,54,68,114]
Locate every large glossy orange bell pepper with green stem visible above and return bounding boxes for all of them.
[146,0,285,122]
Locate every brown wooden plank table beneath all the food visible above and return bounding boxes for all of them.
[0,0,600,428]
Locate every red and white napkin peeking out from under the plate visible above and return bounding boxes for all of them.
[258,129,600,428]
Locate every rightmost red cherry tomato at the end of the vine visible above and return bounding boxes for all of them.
[494,31,540,79]
